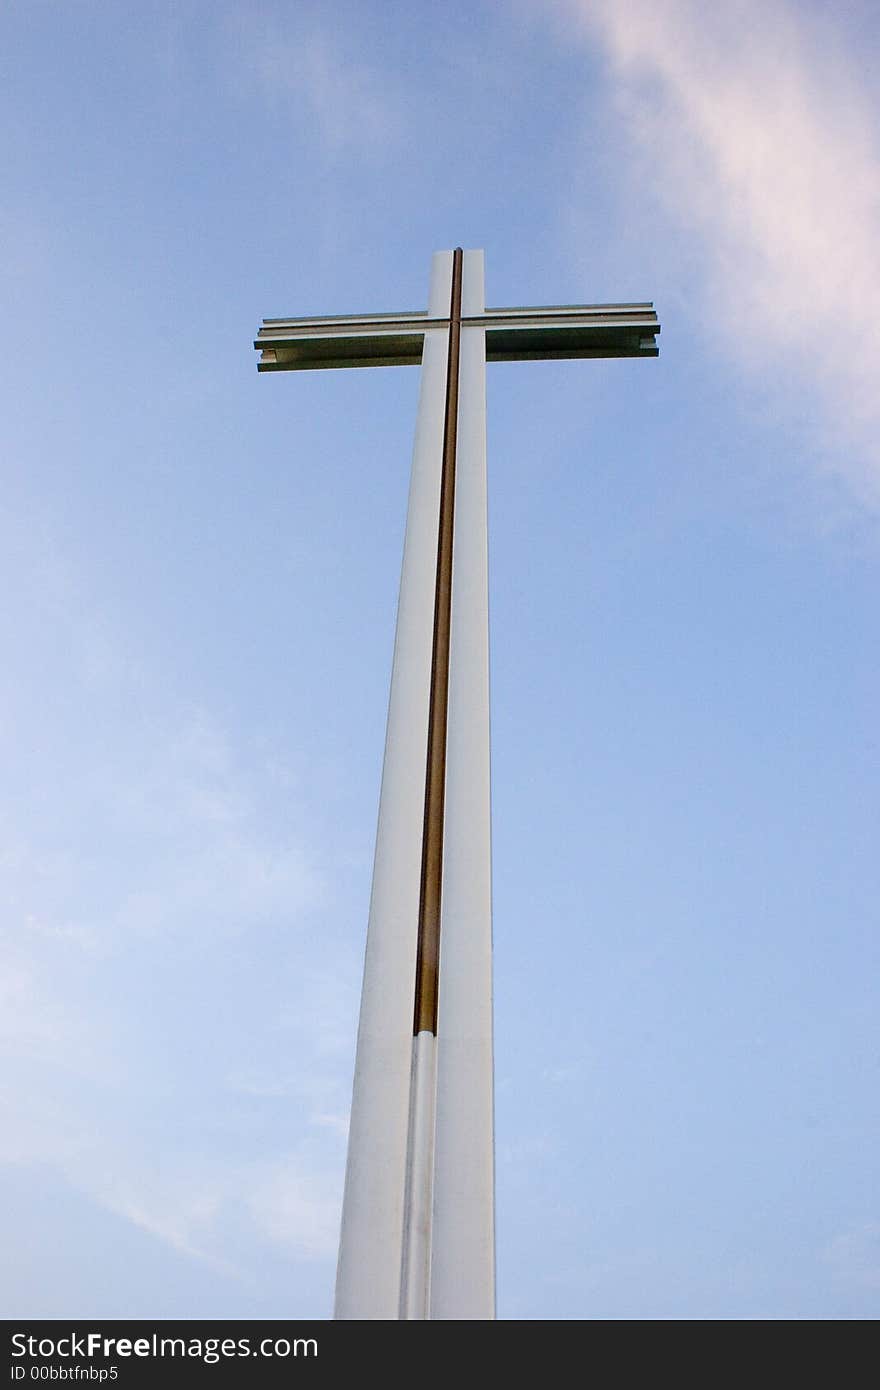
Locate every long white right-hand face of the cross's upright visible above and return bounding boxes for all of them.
[431,252,495,1319]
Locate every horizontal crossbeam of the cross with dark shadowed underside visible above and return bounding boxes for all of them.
[254,303,660,371]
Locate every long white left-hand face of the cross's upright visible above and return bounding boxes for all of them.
[335,252,452,1319]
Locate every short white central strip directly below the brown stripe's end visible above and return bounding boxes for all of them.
[400,1033,437,1319]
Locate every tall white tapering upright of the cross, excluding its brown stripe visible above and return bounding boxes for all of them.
[335,252,495,1319]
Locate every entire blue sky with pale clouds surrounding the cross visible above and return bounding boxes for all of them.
[0,0,880,1319]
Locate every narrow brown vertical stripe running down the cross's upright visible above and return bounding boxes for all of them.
[413,246,463,1034]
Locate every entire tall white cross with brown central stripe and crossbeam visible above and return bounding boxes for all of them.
[254,247,660,1319]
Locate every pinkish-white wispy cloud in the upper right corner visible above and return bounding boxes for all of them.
[556,0,880,507]
